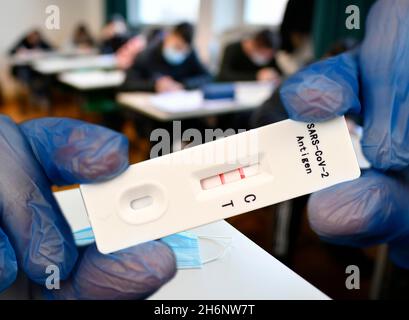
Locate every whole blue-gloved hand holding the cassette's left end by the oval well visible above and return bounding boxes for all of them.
[0,116,176,299]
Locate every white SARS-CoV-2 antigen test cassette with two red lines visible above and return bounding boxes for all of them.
[81,118,360,253]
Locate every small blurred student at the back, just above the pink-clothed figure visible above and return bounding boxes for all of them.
[100,14,130,54]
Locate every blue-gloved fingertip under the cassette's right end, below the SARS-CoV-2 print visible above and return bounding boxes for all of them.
[308,170,409,246]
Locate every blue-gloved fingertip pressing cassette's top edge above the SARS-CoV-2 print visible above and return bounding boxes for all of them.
[280,52,361,122]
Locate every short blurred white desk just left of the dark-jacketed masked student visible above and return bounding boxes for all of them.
[58,70,125,91]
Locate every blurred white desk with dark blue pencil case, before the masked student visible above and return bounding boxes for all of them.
[117,82,274,121]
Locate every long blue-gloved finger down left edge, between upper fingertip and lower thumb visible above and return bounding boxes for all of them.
[0,116,77,284]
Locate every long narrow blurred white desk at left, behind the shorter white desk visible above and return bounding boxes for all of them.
[33,54,117,75]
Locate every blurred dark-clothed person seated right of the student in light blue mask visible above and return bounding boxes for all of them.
[218,29,281,83]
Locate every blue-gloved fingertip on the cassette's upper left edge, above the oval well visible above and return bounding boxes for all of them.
[21,118,128,185]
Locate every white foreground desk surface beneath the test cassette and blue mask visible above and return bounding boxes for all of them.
[56,189,329,300]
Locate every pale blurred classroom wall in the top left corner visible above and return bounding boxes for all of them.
[0,0,104,99]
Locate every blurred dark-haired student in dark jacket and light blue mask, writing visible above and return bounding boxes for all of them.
[121,23,211,92]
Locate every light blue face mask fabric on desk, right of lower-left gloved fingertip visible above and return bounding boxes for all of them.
[161,232,202,269]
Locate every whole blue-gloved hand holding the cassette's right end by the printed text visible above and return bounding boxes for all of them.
[280,0,409,268]
